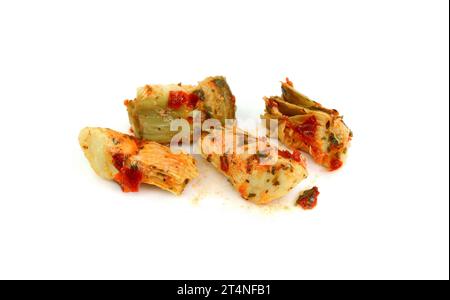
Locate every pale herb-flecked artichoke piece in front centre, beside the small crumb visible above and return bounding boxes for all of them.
[201,130,308,204]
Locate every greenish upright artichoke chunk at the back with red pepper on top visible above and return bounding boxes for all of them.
[125,76,236,144]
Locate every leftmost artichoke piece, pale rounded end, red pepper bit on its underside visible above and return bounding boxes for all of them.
[79,128,198,195]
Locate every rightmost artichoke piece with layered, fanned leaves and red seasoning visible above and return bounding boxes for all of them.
[263,80,353,171]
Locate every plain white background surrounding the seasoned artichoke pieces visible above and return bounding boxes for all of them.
[0,0,449,279]
